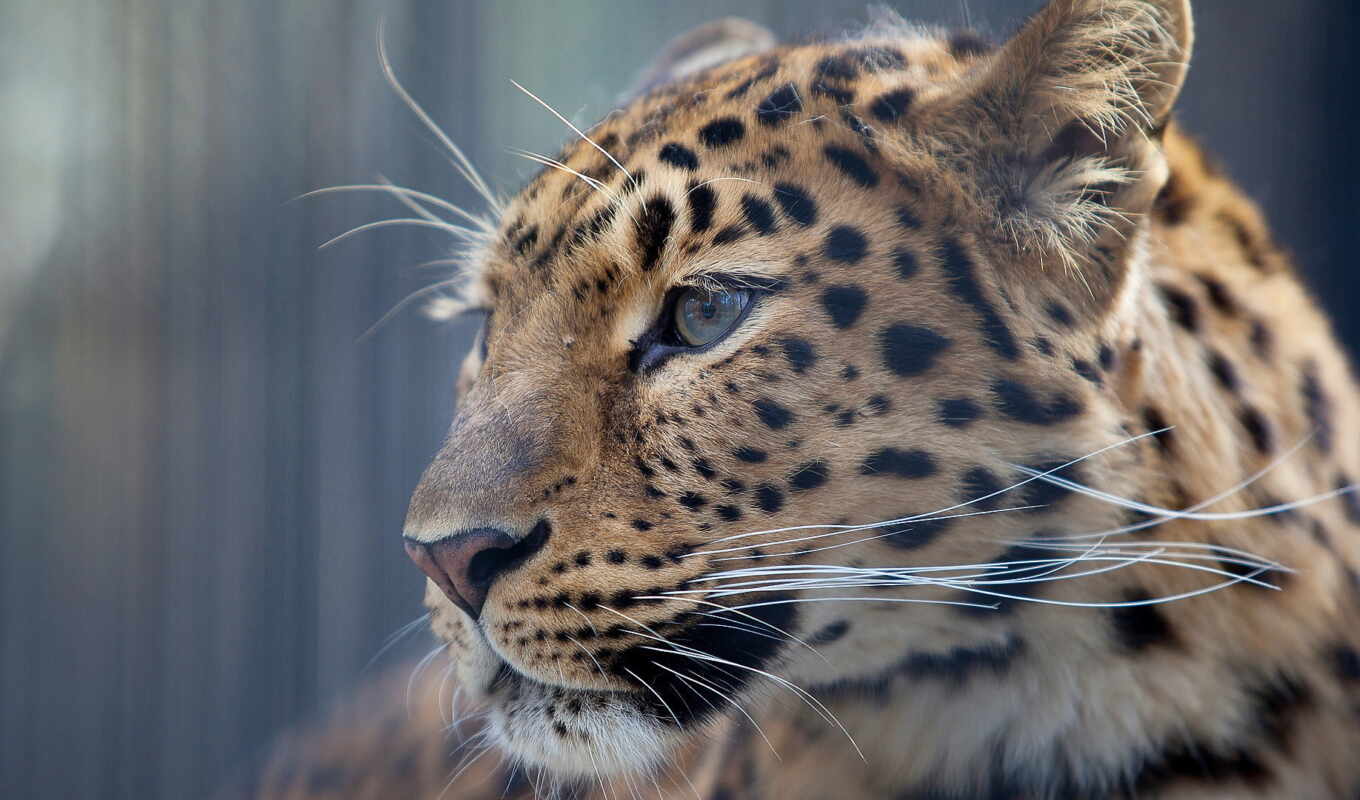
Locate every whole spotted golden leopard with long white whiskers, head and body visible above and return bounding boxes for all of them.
[233,0,1360,800]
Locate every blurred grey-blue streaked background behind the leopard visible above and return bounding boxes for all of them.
[0,0,1360,799]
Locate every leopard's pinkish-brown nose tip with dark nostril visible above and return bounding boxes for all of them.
[405,522,548,619]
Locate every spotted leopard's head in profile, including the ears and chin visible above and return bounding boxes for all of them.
[405,1,1229,777]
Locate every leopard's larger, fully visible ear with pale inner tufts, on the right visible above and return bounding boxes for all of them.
[951,0,1193,267]
